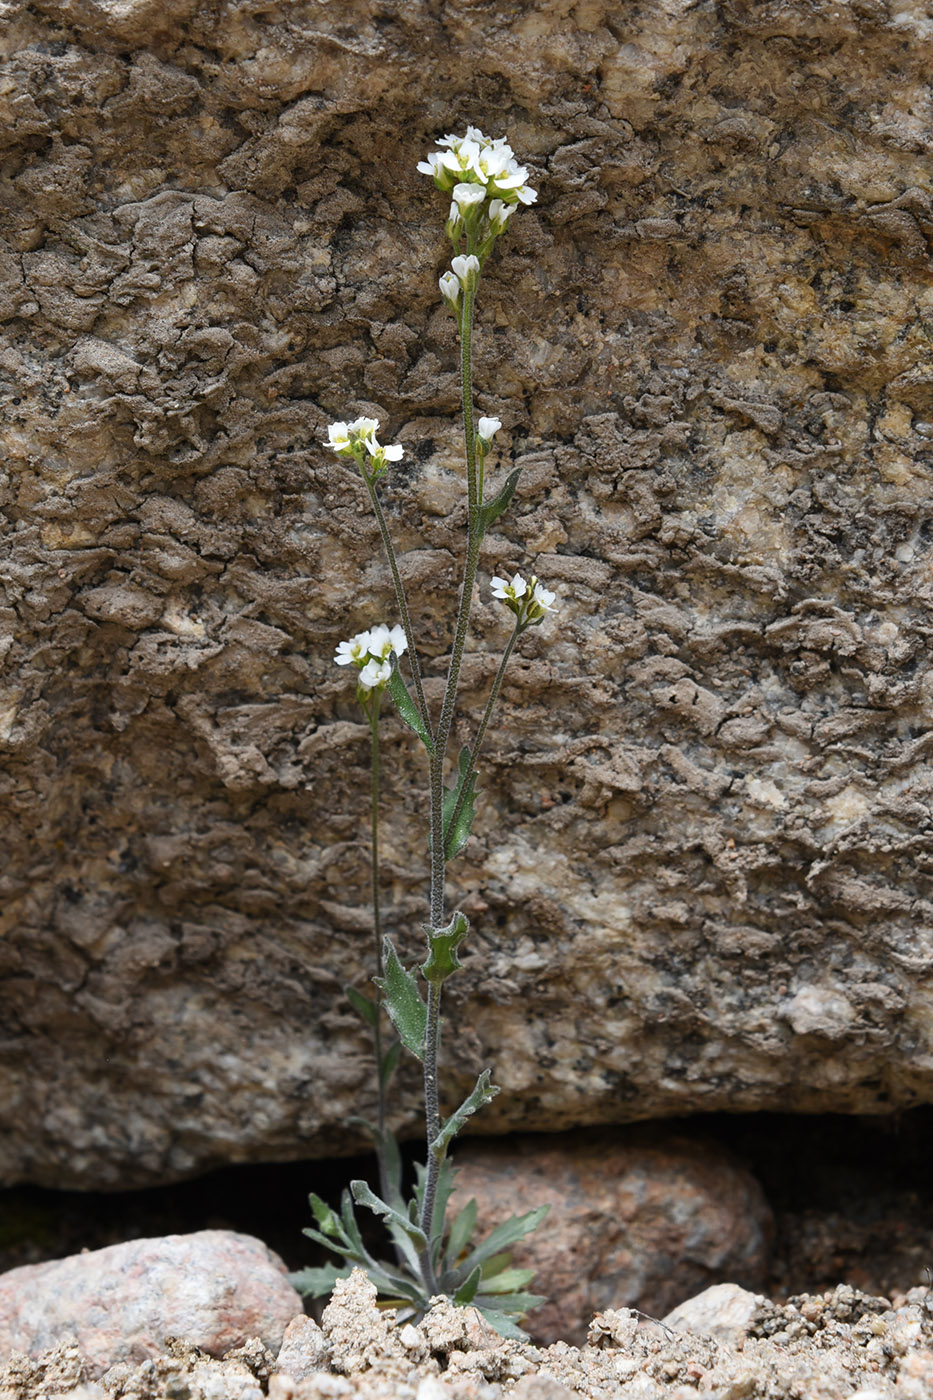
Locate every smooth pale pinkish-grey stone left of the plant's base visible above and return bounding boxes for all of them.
[0,1231,304,1376]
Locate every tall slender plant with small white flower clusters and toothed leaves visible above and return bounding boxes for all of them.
[293,126,555,1337]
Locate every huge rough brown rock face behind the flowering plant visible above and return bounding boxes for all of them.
[0,0,933,1186]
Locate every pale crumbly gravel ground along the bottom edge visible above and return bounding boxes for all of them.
[0,1274,933,1400]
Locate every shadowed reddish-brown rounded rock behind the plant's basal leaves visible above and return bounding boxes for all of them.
[451,1128,773,1344]
